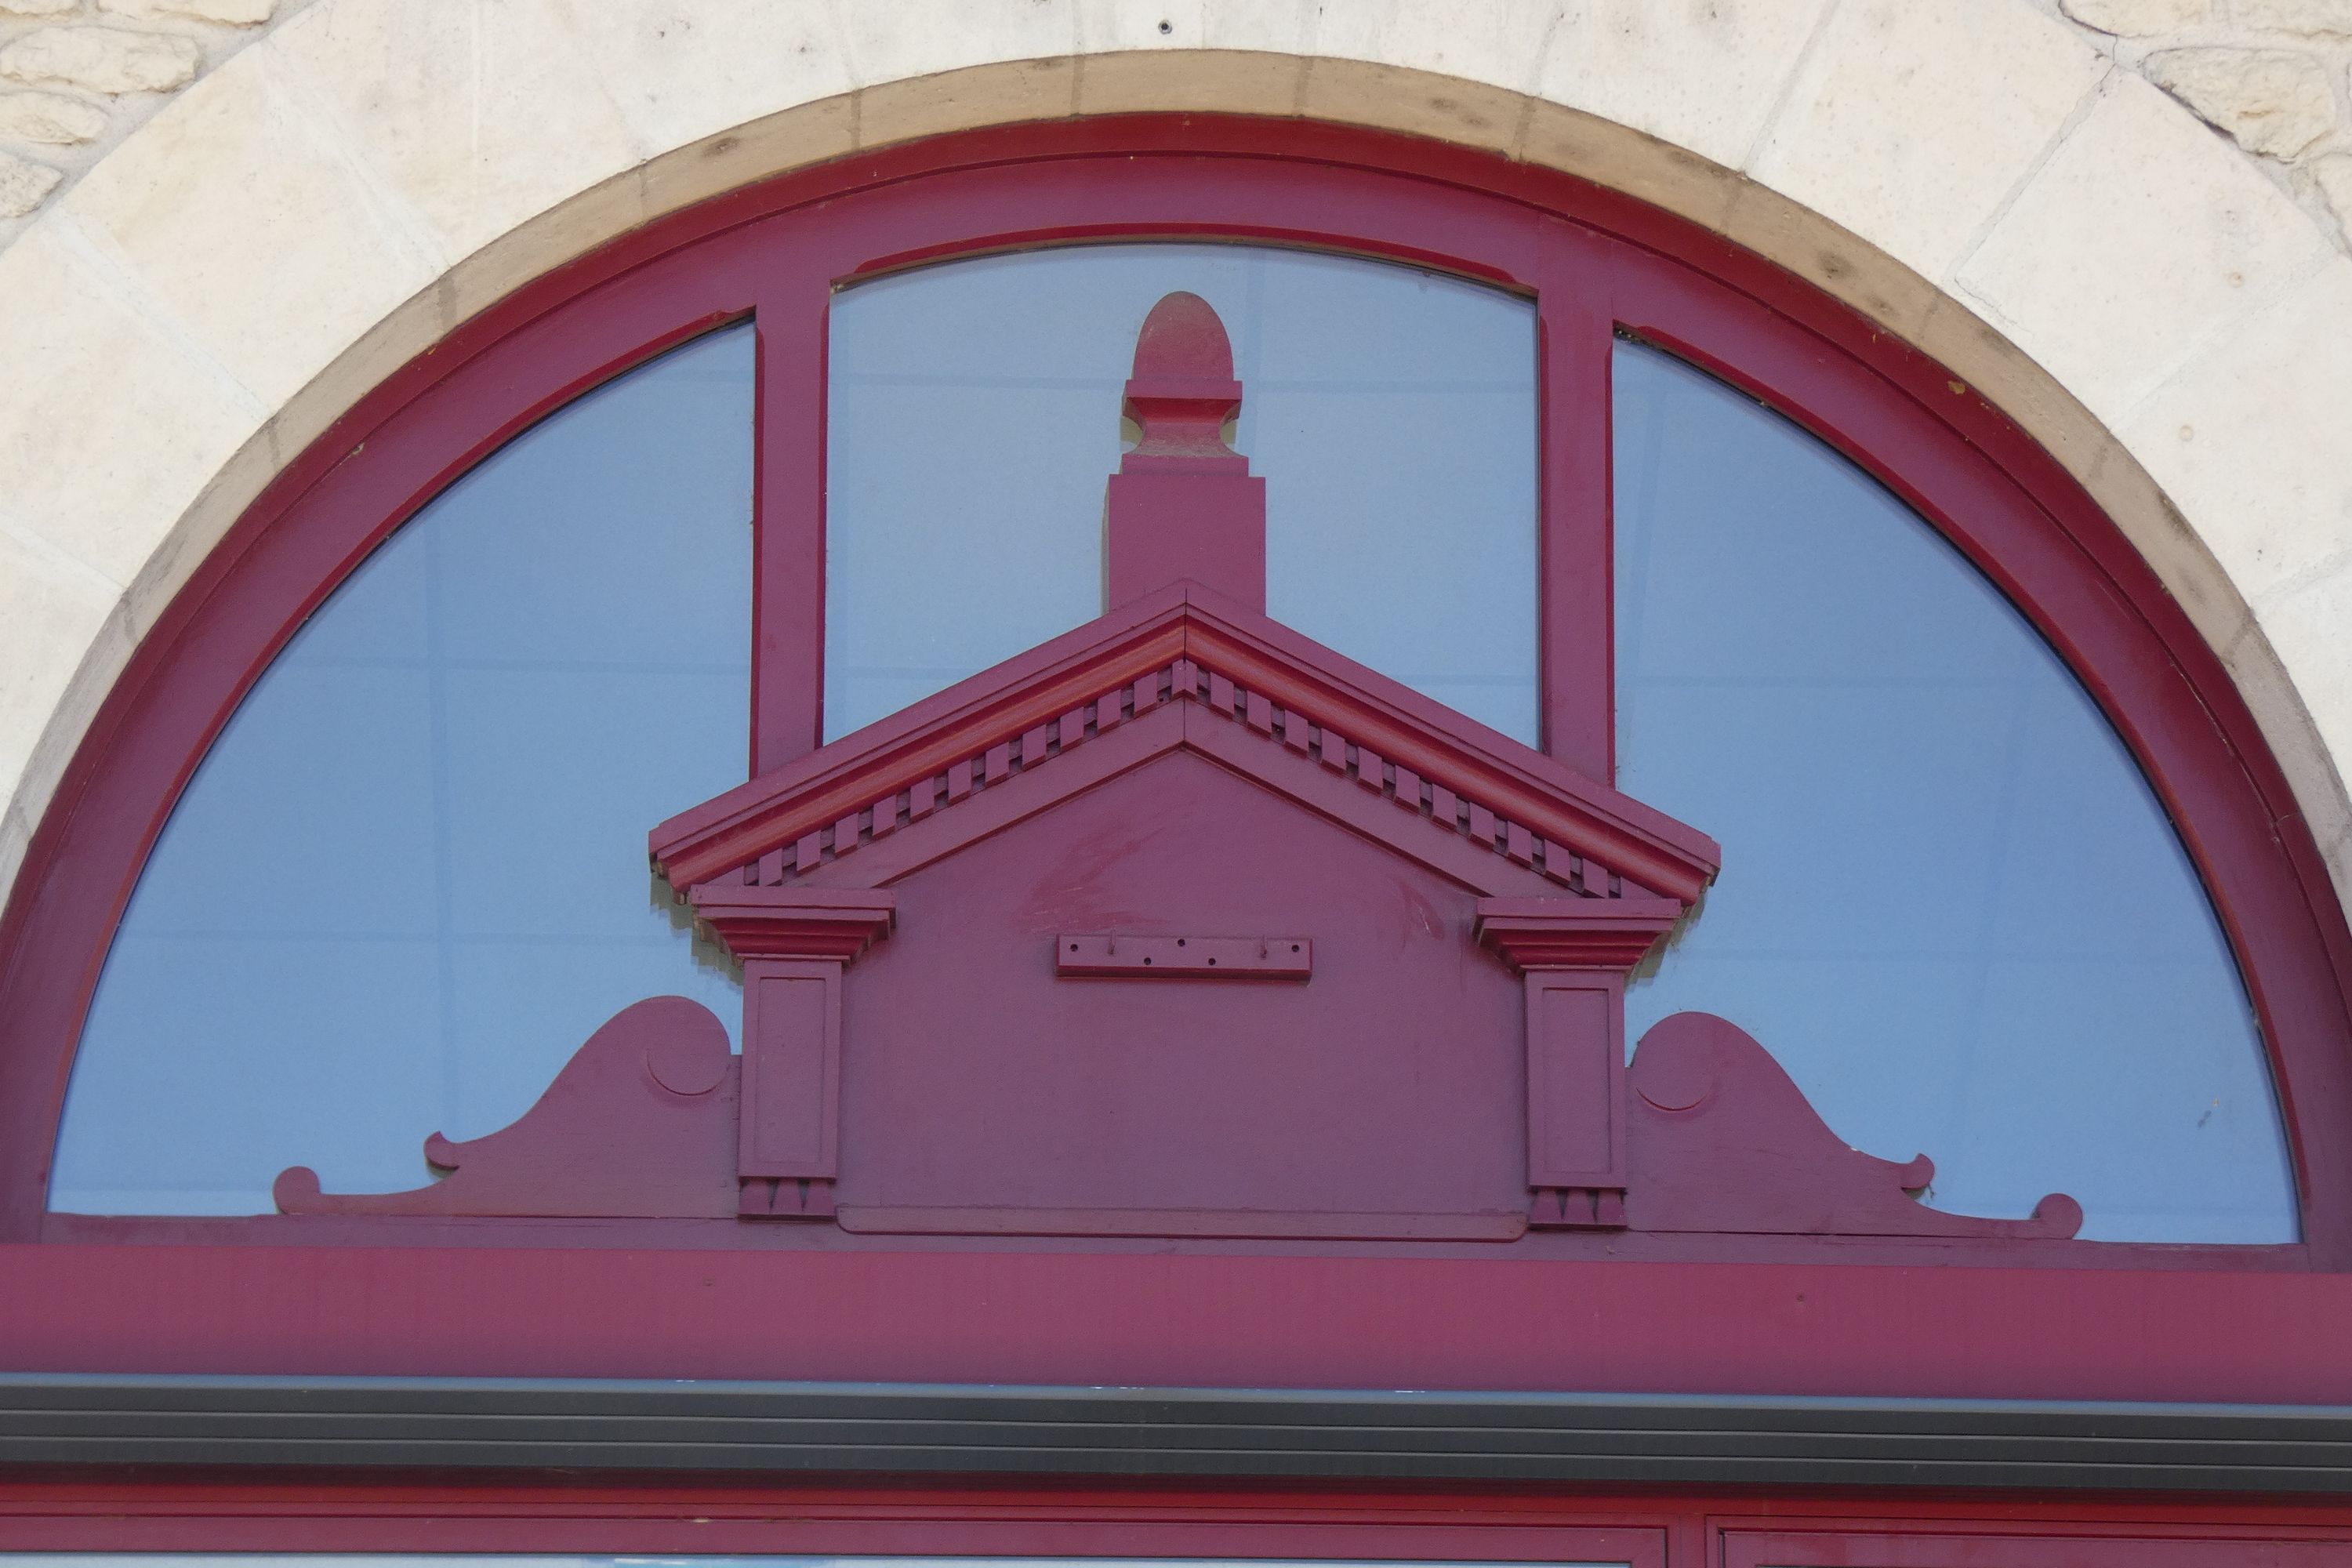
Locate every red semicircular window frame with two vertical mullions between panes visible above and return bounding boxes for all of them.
[0,129,2352,1267]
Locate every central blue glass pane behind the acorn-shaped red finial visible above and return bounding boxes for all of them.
[826,245,1536,746]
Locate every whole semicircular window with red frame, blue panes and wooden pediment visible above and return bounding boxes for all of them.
[0,122,2352,1392]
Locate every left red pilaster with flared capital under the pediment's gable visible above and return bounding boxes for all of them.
[689,881,898,1220]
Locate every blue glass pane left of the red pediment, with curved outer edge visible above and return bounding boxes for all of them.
[49,327,753,1213]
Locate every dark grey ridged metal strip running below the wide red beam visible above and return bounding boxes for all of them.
[0,1373,2352,1495]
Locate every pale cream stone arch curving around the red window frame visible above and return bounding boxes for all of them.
[0,0,2352,921]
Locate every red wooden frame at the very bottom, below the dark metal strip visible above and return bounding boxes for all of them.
[13,1474,2352,1568]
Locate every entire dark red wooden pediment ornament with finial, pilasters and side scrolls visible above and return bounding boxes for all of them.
[278,296,2079,1241]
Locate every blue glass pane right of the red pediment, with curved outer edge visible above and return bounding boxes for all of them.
[1613,343,2296,1241]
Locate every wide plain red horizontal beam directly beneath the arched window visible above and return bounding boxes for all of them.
[0,1243,2352,1403]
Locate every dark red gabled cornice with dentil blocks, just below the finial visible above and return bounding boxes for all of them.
[652,583,1717,902]
